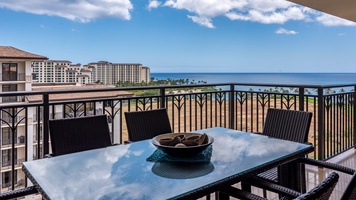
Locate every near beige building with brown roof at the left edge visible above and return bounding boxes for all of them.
[0,46,48,191]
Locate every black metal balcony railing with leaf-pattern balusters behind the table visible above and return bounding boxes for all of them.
[0,83,356,191]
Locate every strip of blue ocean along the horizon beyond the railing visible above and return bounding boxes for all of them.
[151,73,356,85]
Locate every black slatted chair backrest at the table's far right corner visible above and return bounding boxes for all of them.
[263,108,312,143]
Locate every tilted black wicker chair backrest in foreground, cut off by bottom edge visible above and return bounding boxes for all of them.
[295,172,339,200]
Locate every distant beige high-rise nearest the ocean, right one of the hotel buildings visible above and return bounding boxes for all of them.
[83,61,151,85]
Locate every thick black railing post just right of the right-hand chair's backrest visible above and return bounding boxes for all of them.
[317,87,325,160]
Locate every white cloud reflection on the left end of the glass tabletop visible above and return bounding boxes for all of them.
[24,145,128,199]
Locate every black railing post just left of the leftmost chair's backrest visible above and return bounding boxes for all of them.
[42,93,49,156]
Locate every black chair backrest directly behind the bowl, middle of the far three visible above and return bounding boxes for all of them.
[125,108,172,142]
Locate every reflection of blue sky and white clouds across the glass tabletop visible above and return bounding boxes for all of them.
[24,128,308,200]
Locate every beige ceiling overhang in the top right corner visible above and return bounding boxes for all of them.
[288,0,356,22]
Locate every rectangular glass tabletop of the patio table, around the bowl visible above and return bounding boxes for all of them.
[23,127,314,200]
